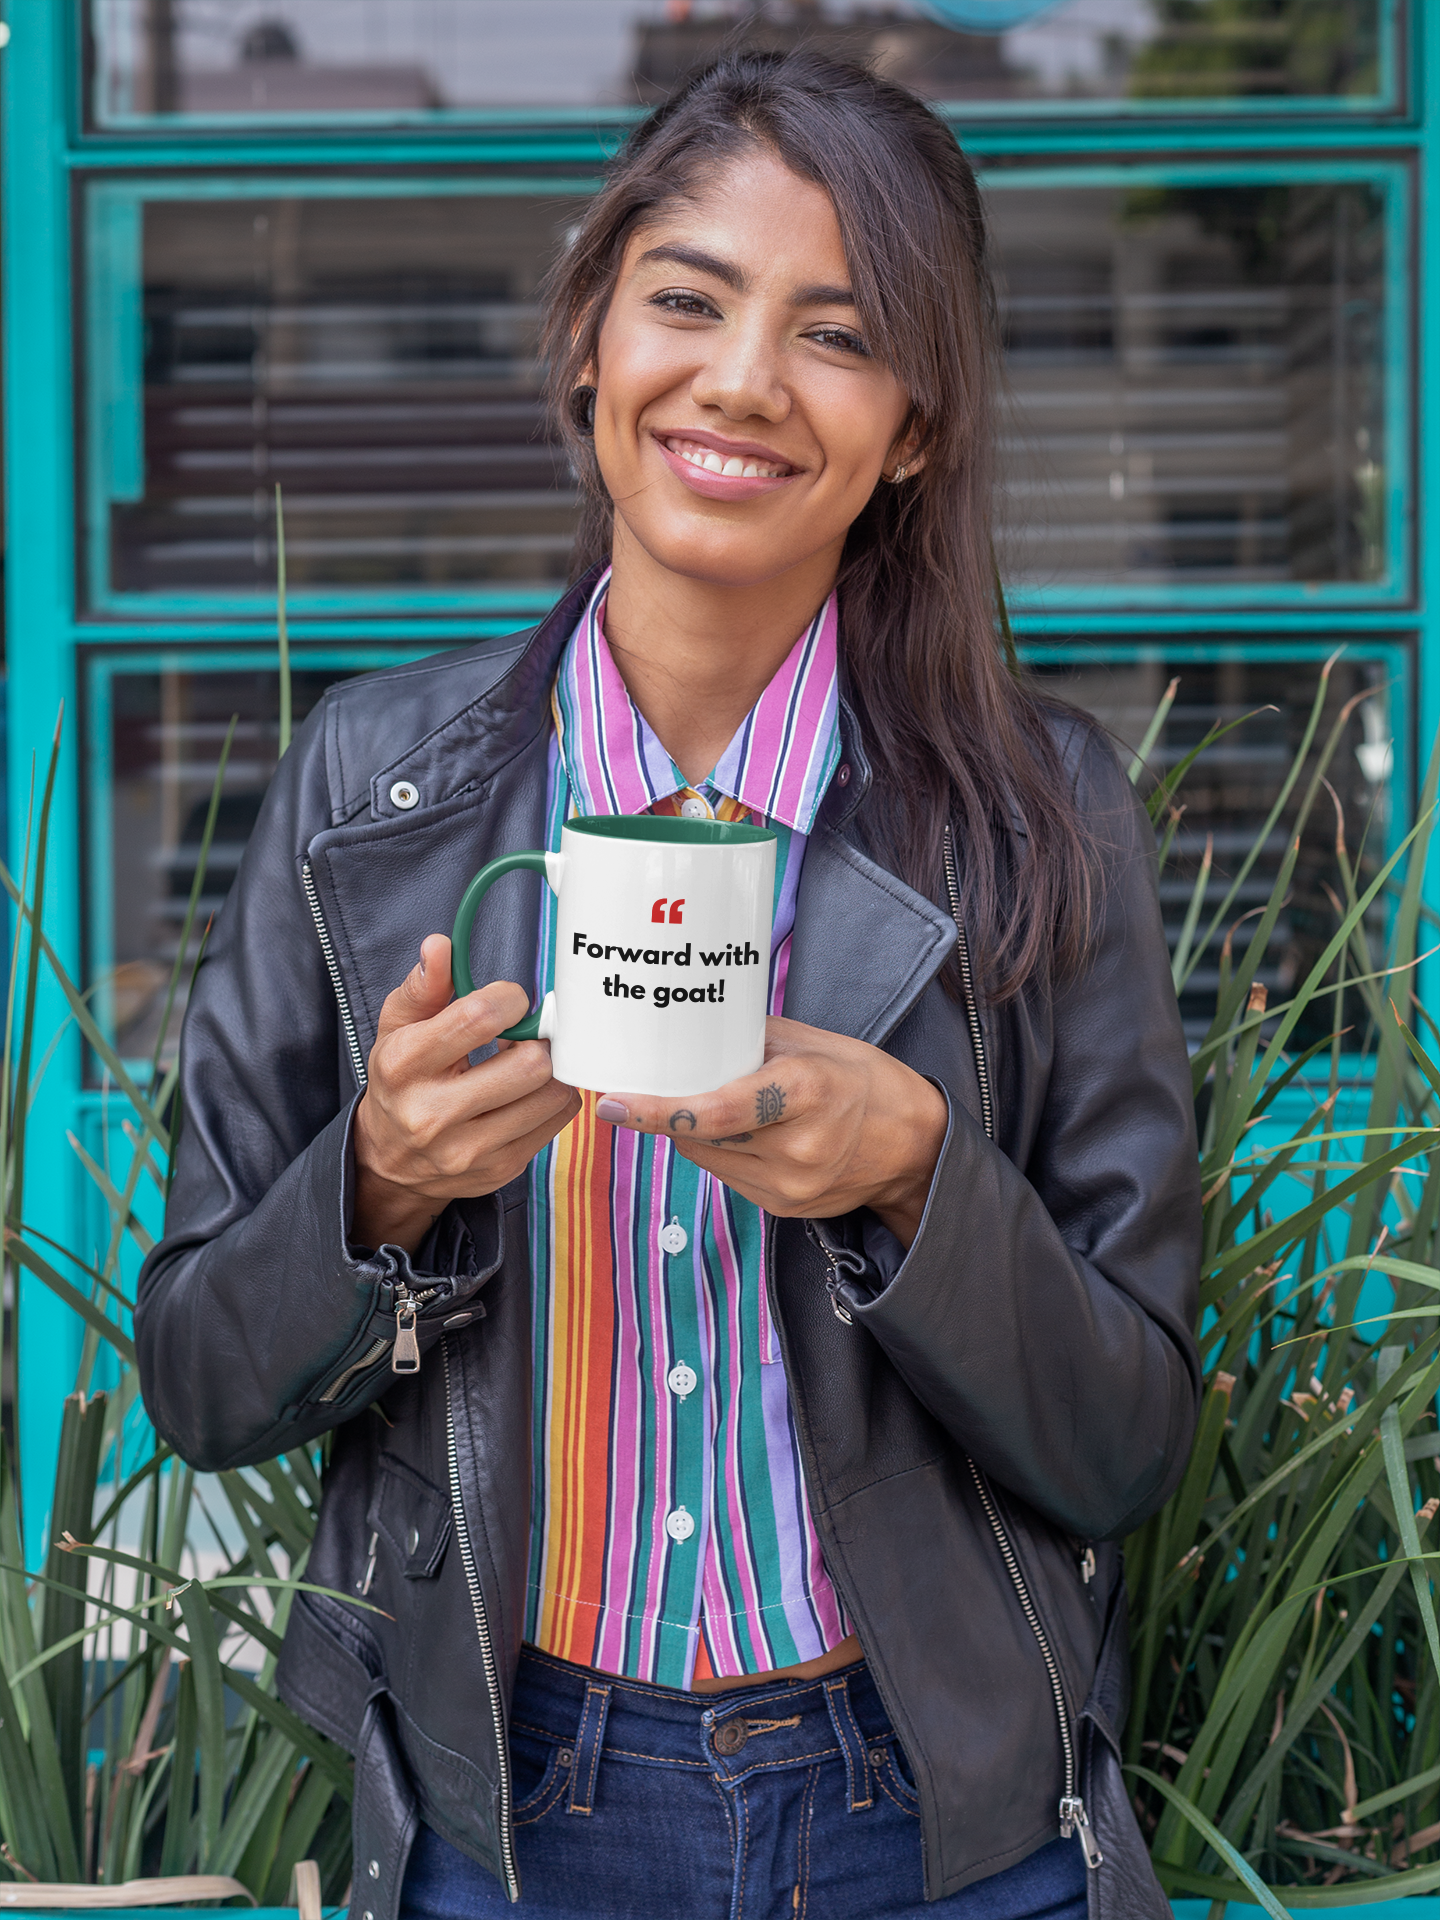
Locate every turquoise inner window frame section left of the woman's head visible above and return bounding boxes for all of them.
[81,173,599,620]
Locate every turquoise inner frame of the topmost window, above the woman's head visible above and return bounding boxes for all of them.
[79,0,1419,140]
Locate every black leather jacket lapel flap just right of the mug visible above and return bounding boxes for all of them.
[785,826,954,1046]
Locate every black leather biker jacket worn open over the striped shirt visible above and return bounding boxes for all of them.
[134,584,1200,1920]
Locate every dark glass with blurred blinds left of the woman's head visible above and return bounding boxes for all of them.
[90,194,580,595]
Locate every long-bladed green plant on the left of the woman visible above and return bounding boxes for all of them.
[0,501,351,1905]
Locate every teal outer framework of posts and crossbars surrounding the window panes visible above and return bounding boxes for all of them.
[0,0,1440,1565]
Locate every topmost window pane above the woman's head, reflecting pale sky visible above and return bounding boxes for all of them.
[90,0,1396,127]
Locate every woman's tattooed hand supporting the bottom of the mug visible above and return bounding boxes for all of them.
[595,1020,948,1248]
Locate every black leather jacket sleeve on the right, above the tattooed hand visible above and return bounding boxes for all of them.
[835,735,1200,1540]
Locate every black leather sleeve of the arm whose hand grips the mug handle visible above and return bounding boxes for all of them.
[134,703,501,1471]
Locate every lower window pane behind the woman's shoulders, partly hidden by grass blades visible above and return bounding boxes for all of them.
[86,643,1409,1060]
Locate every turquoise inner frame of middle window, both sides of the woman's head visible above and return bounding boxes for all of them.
[81,156,1413,620]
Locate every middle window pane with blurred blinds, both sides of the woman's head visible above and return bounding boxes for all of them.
[84,169,1404,611]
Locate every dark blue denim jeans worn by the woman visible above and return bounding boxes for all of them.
[401,1647,1087,1920]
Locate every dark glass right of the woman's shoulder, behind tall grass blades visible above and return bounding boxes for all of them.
[1031,649,1405,1050]
